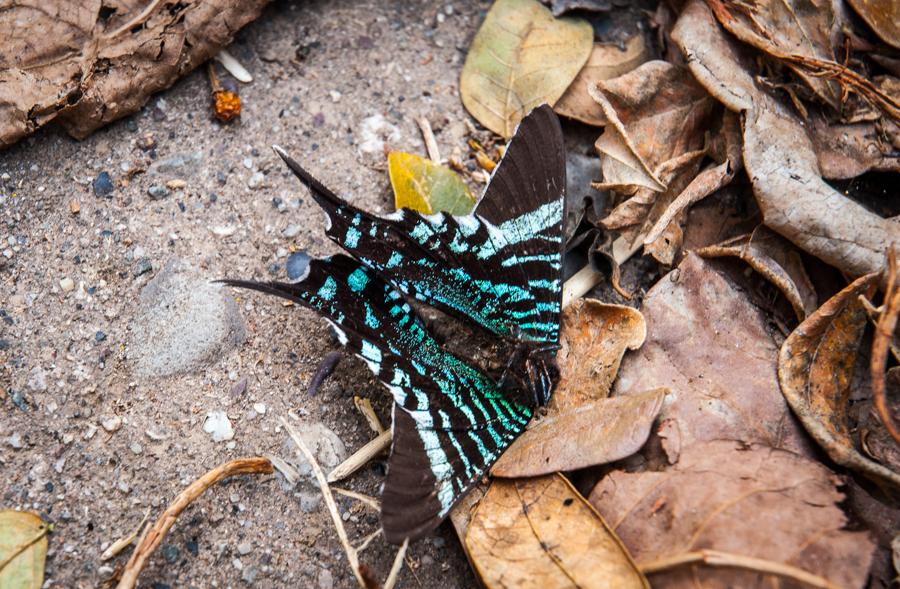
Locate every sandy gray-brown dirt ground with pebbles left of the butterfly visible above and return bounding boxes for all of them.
[0,0,489,589]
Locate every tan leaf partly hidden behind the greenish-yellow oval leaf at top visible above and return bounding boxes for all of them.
[553,35,650,127]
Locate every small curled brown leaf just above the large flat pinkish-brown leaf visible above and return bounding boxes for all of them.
[697,225,818,321]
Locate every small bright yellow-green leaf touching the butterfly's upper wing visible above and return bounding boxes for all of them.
[388,151,476,215]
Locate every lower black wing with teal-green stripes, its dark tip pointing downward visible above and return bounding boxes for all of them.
[223,255,532,543]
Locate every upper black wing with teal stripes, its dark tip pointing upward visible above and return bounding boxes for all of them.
[276,105,566,344]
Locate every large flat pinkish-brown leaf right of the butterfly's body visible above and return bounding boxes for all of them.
[614,254,808,453]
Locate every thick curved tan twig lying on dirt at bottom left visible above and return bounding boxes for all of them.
[117,457,272,589]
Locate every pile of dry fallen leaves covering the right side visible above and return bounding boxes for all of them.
[442,0,900,588]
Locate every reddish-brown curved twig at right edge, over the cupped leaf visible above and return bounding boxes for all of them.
[869,246,900,444]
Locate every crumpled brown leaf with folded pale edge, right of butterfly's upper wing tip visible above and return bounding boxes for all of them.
[589,61,715,194]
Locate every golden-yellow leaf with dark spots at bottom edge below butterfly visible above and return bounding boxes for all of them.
[466,475,649,589]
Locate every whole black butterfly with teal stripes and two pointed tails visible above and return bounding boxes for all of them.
[222,105,566,543]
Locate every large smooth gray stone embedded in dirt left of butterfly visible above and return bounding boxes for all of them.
[128,260,245,376]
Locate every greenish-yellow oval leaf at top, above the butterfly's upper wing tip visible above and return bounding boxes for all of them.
[459,0,594,137]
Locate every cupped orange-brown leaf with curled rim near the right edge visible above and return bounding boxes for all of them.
[778,273,900,488]
